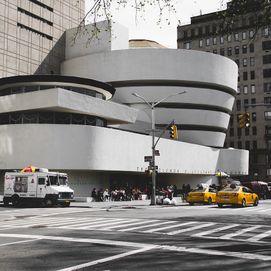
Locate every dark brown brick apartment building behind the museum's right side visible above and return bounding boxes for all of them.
[178,4,271,181]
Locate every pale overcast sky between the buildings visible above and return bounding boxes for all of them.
[86,0,230,48]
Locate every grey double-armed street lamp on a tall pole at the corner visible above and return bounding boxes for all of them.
[132,91,186,205]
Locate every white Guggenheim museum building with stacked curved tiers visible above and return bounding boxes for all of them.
[0,22,249,196]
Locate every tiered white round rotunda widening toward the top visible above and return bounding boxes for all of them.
[62,48,238,147]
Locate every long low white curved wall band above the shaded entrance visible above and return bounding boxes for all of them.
[0,124,248,176]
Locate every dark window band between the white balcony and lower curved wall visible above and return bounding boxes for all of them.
[0,111,106,126]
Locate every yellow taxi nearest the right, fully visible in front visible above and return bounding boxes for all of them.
[216,184,259,207]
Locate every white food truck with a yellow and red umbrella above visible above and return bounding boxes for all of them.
[3,169,74,207]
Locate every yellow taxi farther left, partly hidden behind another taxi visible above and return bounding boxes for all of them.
[186,185,216,205]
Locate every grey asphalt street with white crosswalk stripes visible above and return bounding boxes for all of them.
[0,200,271,270]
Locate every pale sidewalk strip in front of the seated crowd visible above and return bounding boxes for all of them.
[71,197,187,208]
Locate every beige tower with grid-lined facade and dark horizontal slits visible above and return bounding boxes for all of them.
[0,0,85,77]
